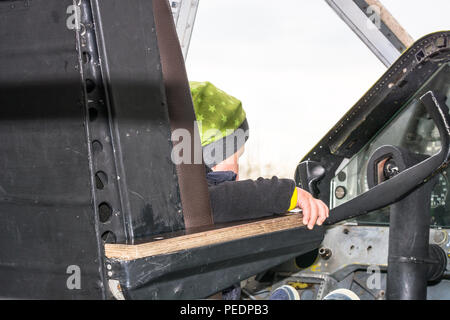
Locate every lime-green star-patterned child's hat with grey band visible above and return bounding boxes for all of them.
[190,81,248,165]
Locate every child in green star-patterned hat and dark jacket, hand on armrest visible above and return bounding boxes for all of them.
[190,82,329,229]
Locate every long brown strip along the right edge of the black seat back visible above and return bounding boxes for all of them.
[153,0,213,228]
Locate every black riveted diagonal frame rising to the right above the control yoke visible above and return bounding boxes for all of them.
[296,31,450,210]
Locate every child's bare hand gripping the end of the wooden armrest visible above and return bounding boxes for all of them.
[297,188,330,230]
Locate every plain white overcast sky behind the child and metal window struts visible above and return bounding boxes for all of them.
[187,0,450,178]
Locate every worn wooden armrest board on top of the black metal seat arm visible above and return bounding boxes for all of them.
[105,214,303,261]
